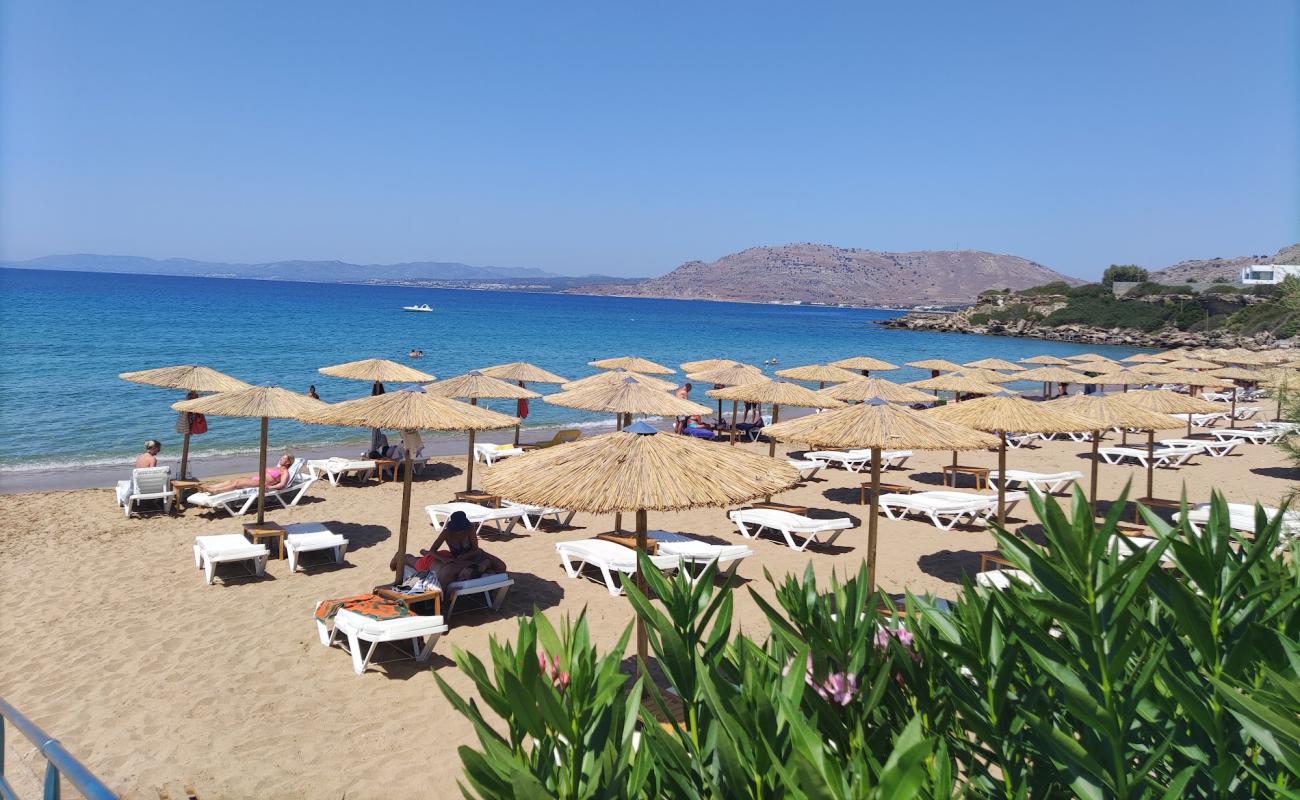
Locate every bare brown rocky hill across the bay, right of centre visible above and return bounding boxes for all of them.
[576,245,1083,307]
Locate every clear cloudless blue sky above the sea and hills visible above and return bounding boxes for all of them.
[0,0,1300,277]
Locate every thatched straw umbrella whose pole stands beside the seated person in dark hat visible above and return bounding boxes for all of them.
[306,384,516,583]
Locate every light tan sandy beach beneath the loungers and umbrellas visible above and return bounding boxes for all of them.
[0,432,1294,797]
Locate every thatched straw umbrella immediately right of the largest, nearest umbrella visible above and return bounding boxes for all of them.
[767,397,997,592]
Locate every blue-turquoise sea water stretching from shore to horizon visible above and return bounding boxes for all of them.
[0,269,1149,473]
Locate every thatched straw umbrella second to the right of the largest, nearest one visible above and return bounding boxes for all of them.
[926,392,1105,526]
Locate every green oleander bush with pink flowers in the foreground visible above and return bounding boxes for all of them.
[438,492,1300,799]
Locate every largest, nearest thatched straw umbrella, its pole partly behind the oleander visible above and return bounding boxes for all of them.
[484,426,800,663]
